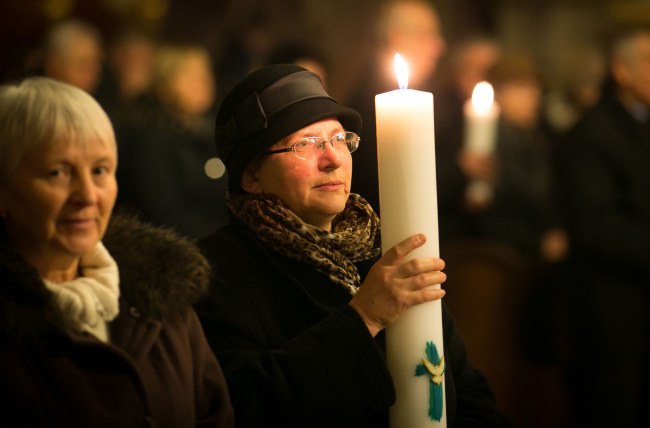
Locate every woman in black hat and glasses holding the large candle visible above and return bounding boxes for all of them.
[198,65,508,427]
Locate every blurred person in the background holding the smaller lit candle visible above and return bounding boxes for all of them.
[460,55,568,264]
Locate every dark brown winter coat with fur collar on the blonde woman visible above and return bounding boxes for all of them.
[0,218,233,428]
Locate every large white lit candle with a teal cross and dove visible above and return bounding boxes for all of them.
[375,55,447,428]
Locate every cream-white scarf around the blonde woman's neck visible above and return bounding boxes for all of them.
[43,242,120,342]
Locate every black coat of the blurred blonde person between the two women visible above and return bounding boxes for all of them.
[115,101,228,238]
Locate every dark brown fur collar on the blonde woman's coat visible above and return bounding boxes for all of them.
[0,215,210,343]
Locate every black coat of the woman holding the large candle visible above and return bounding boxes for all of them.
[198,224,508,427]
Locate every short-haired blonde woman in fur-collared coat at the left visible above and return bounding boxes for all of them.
[0,78,233,428]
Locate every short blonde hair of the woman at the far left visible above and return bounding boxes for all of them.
[0,77,117,183]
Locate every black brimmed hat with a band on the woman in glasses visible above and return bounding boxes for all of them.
[215,64,361,191]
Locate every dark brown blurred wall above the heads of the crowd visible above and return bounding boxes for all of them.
[5,0,650,98]
